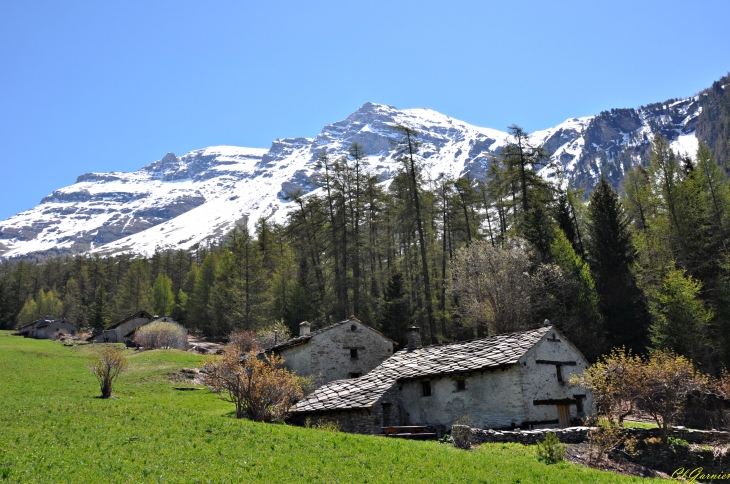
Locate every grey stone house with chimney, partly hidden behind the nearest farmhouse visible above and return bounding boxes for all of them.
[266,317,396,383]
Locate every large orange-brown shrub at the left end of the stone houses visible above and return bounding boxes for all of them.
[203,347,302,422]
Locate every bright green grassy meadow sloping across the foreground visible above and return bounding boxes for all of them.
[0,331,656,484]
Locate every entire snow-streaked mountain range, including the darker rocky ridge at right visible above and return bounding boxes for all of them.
[0,75,726,258]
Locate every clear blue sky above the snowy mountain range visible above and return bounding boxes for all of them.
[0,0,730,219]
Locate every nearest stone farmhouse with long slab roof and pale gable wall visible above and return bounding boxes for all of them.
[292,326,593,434]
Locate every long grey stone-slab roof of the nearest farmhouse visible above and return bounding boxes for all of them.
[292,326,552,413]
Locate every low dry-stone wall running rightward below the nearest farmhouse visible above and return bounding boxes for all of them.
[452,425,730,445]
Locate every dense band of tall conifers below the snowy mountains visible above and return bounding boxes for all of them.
[0,126,730,374]
